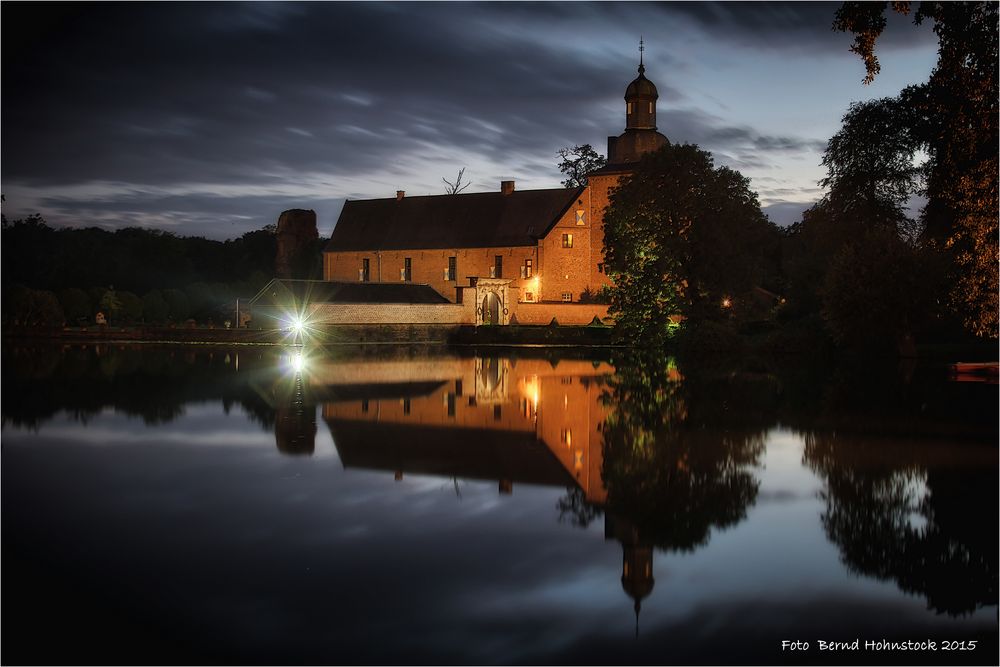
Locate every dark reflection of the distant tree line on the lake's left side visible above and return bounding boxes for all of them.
[2,343,316,438]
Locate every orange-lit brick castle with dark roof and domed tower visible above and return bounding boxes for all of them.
[323,53,668,314]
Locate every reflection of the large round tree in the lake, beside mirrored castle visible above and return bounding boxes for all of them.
[602,356,764,551]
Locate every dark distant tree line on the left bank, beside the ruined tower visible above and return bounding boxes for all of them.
[0,215,277,326]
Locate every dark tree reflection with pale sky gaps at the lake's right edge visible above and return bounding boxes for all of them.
[804,433,998,616]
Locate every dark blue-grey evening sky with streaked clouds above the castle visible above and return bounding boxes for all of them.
[0,2,936,239]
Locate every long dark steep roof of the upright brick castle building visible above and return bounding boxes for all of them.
[326,188,583,252]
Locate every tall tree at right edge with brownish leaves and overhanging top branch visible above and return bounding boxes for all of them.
[834,2,1000,336]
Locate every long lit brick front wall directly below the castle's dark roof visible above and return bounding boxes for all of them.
[323,246,539,302]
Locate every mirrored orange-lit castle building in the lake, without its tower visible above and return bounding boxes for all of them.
[311,357,613,503]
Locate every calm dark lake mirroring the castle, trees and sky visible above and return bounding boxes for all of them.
[2,345,998,664]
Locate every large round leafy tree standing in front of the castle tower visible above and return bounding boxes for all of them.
[604,144,778,346]
